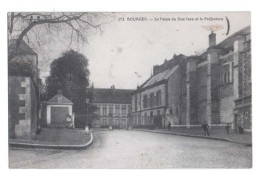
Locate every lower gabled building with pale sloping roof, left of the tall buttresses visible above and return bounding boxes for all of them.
[131,55,186,127]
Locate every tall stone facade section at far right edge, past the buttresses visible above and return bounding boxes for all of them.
[233,28,252,131]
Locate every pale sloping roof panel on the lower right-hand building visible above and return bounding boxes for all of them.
[141,65,179,88]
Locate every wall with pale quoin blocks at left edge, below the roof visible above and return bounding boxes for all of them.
[8,76,38,139]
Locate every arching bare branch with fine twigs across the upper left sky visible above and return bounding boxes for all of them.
[8,12,114,61]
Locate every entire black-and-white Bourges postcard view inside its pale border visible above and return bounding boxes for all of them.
[6,11,253,169]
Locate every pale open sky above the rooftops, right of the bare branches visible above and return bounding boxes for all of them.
[38,12,251,89]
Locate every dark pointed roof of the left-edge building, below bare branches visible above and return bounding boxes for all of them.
[8,39,37,55]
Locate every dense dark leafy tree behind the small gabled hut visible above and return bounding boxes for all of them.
[46,50,89,114]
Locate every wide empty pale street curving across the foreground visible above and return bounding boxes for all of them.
[9,130,252,169]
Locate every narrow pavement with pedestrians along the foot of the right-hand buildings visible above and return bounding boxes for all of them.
[133,127,252,146]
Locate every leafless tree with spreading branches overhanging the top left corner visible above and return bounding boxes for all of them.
[8,12,114,60]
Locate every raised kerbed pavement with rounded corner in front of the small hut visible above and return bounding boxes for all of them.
[9,128,93,149]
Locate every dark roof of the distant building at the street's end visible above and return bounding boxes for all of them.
[89,88,134,104]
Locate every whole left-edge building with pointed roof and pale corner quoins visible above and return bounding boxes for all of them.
[8,40,40,139]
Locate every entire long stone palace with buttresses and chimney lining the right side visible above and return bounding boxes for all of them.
[131,26,251,130]
